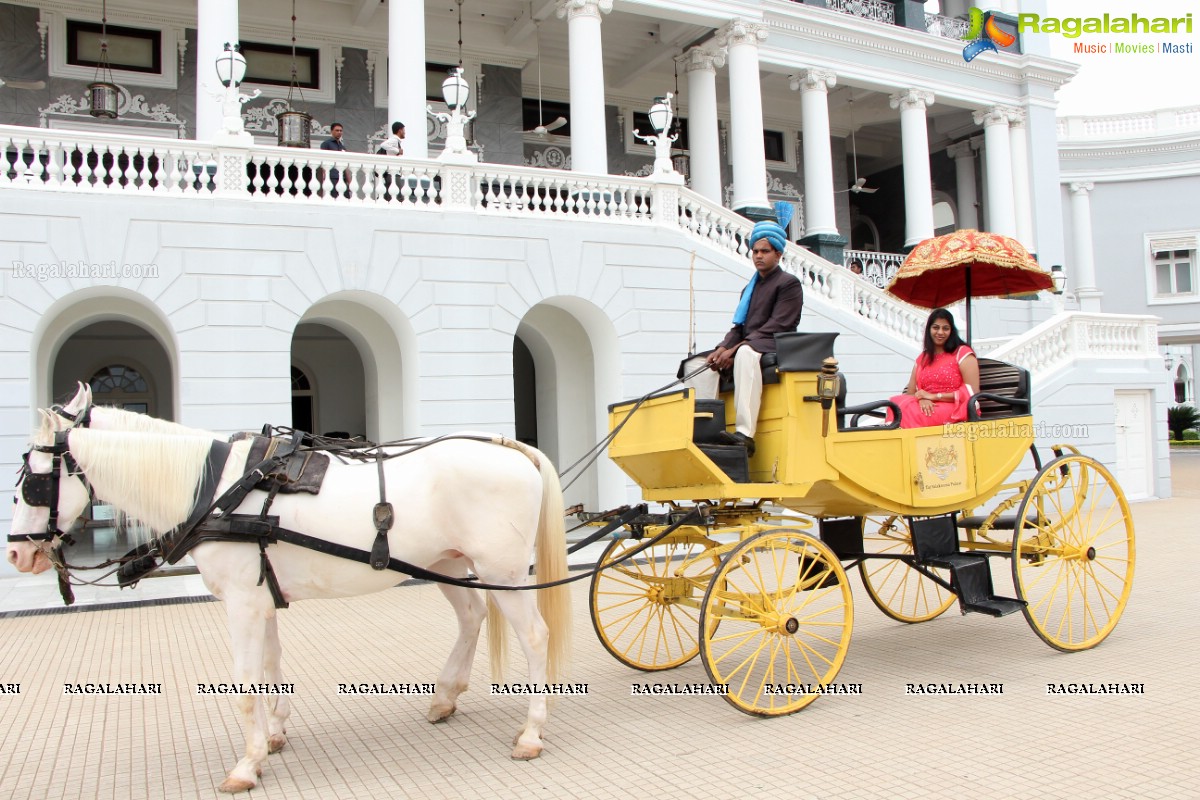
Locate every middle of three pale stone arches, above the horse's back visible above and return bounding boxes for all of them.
[293,290,419,441]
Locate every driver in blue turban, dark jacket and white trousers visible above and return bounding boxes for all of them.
[680,203,804,456]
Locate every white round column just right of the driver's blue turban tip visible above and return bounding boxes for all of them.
[791,70,838,236]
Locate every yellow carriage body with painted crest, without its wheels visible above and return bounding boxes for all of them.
[608,372,1033,517]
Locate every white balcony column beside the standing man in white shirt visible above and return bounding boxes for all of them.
[386,0,430,158]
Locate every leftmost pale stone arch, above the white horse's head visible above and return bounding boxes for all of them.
[30,287,180,420]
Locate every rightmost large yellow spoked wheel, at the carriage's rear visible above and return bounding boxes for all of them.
[1013,455,1134,650]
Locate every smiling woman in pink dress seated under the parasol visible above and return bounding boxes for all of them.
[888,308,979,428]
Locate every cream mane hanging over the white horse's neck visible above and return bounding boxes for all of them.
[63,428,219,535]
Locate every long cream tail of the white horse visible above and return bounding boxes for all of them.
[529,447,571,682]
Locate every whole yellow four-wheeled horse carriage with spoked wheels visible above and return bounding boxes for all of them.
[590,333,1134,716]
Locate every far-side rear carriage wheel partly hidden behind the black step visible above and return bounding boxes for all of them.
[858,517,955,622]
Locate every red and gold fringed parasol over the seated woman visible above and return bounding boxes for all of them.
[888,229,1054,345]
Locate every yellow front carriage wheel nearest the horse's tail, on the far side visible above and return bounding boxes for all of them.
[590,535,720,670]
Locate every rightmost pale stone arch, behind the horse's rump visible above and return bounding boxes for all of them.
[514,296,625,510]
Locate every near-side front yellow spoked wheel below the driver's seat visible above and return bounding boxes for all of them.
[700,529,854,716]
